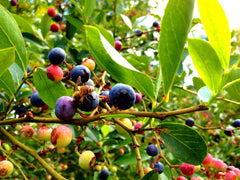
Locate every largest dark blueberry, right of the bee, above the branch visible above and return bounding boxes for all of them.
[109,83,136,110]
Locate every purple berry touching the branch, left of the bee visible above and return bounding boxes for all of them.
[55,96,76,121]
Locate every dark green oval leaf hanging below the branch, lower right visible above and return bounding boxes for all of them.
[160,123,207,165]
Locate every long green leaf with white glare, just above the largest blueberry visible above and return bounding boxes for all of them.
[85,26,154,100]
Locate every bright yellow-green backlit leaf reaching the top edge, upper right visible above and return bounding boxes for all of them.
[198,0,231,69]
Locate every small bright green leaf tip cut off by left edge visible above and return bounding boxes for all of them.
[0,47,15,76]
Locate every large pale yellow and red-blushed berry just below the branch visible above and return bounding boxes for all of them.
[51,125,72,147]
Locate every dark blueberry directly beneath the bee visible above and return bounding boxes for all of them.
[78,91,99,111]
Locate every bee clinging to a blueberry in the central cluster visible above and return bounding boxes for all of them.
[73,76,95,106]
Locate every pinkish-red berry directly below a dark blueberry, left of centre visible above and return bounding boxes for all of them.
[47,65,63,82]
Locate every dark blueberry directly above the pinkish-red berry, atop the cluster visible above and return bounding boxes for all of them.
[48,47,66,65]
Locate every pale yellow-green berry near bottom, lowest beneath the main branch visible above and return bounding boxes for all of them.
[78,150,96,169]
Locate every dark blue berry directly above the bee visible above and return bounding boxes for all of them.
[70,65,91,83]
